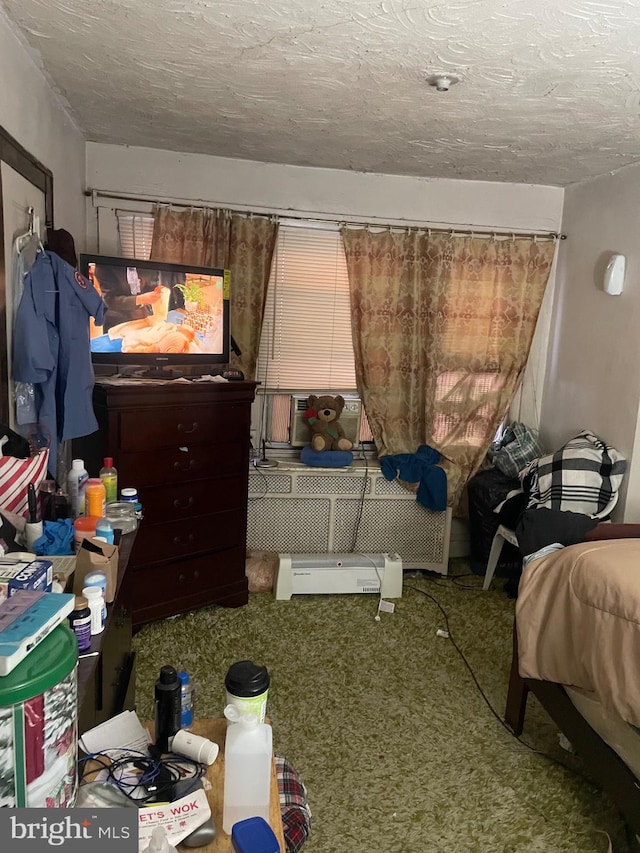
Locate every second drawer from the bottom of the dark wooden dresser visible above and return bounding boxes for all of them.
[131,507,242,566]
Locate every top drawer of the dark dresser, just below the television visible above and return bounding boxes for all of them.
[118,403,250,451]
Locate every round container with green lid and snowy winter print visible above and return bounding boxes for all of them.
[0,625,78,808]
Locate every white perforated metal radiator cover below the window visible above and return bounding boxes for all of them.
[247,463,451,574]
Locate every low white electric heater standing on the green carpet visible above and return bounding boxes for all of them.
[275,554,402,600]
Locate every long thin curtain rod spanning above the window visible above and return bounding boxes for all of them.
[84,189,567,241]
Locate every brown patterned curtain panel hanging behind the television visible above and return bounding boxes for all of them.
[151,206,278,379]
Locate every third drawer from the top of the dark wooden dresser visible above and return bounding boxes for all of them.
[139,474,246,525]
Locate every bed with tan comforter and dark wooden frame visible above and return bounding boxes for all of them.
[505,524,640,835]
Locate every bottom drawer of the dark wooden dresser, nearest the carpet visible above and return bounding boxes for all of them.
[128,548,246,621]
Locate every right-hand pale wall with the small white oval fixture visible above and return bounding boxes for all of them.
[541,161,640,521]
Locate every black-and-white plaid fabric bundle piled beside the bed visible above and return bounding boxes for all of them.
[520,431,627,516]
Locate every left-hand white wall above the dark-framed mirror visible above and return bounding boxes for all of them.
[0,8,86,246]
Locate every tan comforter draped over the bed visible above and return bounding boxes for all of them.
[516,539,640,726]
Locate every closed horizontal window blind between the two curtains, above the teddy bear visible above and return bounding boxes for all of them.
[258,225,356,391]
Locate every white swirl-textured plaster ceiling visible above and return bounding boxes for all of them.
[0,0,640,186]
